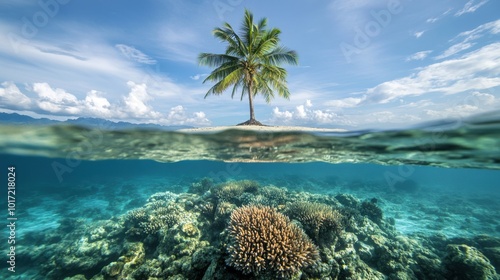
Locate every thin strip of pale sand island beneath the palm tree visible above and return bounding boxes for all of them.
[178,125,347,133]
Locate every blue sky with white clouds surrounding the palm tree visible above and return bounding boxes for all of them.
[0,0,500,129]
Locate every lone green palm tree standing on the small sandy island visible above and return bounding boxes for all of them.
[198,10,298,125]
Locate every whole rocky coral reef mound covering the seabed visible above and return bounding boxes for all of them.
[12,178,500,280]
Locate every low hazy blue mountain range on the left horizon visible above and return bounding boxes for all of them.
[0,113,193,130]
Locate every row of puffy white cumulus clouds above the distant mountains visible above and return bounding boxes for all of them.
[0,81,210,126]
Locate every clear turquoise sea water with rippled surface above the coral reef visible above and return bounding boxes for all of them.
[0,112,500,279]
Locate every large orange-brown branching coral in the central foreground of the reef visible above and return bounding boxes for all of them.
[227,206,319,278]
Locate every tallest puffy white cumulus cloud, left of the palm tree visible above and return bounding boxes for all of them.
[123,81,161,119]
